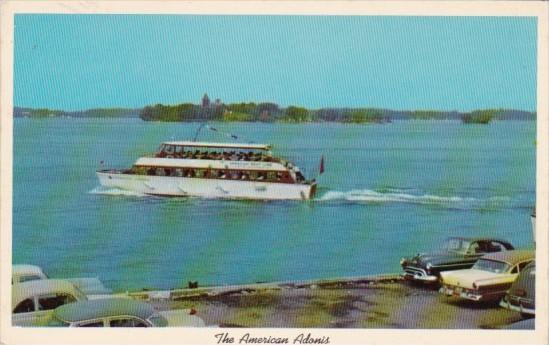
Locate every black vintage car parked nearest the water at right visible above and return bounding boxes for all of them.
[400,237,513,283]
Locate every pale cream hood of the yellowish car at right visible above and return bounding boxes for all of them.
[440,269,517,289]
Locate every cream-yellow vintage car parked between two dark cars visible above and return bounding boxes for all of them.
[440,250,535,301]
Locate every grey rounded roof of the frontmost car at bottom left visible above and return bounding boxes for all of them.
[55,298,155,322]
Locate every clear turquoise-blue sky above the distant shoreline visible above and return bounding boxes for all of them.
[14,14,537,111]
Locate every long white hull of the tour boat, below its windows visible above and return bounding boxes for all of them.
[97,171,316,200]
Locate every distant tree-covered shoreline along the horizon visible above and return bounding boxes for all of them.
[13,103,536,124]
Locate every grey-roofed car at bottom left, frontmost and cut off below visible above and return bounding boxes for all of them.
[48,298,205,327]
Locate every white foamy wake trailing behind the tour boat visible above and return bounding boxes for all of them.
[318,189,510,209]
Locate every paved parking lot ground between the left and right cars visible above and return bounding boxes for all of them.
[164,280,521,329]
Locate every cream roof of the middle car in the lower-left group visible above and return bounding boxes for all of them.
[11,279,85,306]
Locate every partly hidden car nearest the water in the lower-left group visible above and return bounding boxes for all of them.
[11,264,112,298]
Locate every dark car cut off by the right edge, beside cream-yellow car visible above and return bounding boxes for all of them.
[499,261,536,317]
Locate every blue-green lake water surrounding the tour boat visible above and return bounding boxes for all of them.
[13,118,536,291]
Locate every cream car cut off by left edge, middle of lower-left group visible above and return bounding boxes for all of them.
[11,279,87,326]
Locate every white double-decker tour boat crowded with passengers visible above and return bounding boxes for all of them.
[97,141,316,200]
